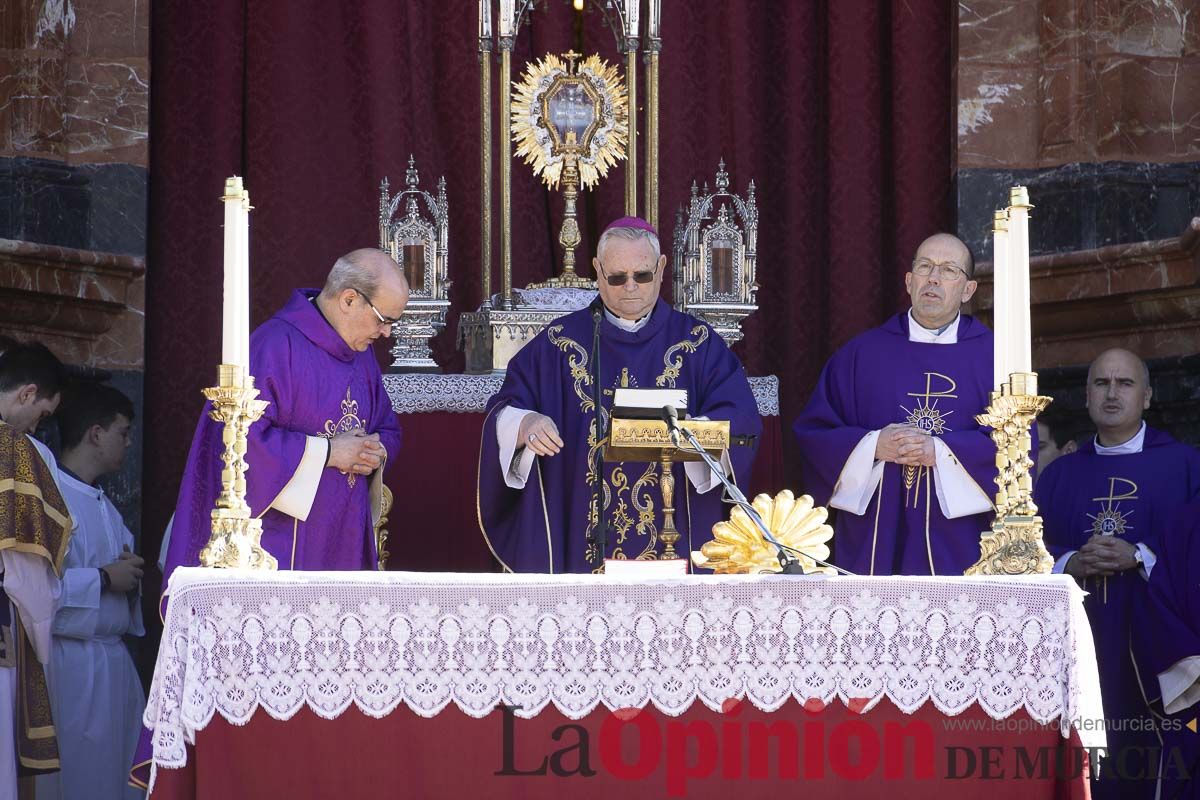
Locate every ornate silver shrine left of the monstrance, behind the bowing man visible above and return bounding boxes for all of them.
[379,156,452,372]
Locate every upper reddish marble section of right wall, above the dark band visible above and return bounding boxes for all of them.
[956,0,1200,169]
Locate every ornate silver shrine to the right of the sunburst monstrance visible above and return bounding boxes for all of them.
[672,158,758,344]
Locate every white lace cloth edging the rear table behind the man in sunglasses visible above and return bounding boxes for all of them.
[383,373,779,416]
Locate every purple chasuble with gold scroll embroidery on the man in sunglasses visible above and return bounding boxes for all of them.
[479,300,762,572]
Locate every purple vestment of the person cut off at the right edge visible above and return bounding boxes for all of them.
[1133,495,1200,800]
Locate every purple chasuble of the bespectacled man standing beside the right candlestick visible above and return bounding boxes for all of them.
[793,312,998,575]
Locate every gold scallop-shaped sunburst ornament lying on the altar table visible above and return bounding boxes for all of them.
[691,489,834,575]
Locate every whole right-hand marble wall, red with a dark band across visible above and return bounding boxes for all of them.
[955,0,1200,371]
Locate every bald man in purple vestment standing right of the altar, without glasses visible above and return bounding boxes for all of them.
[1033,349,1200,800]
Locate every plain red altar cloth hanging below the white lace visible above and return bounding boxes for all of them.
[152,699,1088,800]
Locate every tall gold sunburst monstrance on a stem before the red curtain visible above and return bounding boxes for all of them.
[511,52,629,288]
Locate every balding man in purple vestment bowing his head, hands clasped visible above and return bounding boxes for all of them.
[163,249,408,577]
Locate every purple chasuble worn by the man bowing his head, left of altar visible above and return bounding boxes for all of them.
[163,289,400,587]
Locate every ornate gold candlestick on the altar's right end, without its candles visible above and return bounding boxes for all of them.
[966,372,1054,575]
